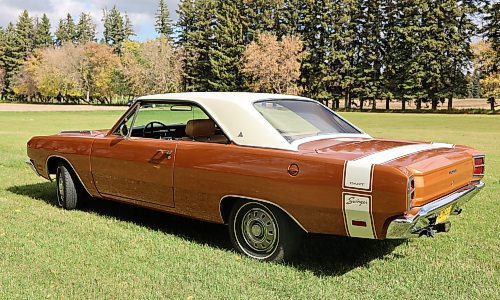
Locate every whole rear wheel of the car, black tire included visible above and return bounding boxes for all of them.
[229,201,303,262]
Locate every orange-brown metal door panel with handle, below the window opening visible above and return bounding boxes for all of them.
[91,135,177,207]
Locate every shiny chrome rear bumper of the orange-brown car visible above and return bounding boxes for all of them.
[386,182,484,239]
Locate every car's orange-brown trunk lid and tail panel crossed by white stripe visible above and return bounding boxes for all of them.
[300,138,473,206]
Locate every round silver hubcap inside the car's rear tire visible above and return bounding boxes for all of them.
[241,208,277,252]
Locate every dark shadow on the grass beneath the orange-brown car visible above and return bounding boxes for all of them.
[7,182,404,276]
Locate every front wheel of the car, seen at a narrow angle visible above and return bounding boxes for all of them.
[56,163,81,210]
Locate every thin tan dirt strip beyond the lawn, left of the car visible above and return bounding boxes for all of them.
[0,103,128,111]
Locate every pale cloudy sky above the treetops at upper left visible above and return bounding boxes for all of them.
[0,0,179,41]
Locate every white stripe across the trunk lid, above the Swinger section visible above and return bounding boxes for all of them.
[342,143,454,192]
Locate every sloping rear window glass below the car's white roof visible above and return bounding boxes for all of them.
[254,100,361,143]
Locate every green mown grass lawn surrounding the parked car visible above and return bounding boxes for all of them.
[0,111,500,299]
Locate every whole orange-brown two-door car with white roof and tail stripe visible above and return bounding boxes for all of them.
[27,93,485,261]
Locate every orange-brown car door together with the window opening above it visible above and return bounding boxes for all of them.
[90,105,178,207]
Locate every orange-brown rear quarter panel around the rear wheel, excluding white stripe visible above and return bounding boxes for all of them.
[174,142,406,237]
